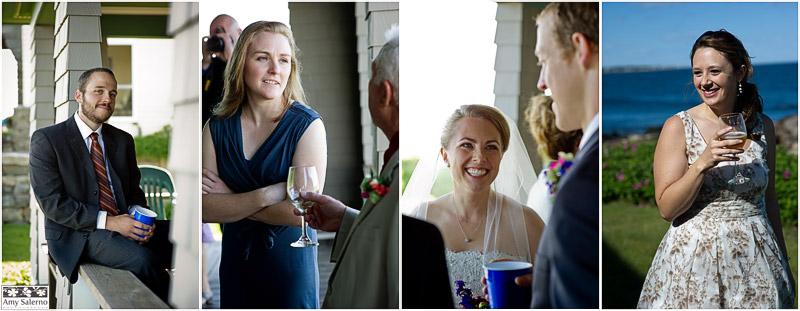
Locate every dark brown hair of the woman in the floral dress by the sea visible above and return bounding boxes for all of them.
[689,29,764,136]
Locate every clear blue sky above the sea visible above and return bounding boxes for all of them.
[602,2,797,68]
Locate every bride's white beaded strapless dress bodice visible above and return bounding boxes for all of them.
[445,249,526,309]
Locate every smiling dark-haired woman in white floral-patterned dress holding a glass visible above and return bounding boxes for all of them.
[638,30,795,309]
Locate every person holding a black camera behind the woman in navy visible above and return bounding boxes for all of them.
[200,14,242,126]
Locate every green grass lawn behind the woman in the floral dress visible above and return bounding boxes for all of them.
[603,202,797,309]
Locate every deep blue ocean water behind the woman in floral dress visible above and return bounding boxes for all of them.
[602,63,797,134]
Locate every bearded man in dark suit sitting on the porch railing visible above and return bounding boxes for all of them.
[29,68,172,302]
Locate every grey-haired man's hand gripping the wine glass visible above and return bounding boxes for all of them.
[294,192,347,232]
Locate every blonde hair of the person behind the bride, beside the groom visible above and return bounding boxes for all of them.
[525,94,582,160]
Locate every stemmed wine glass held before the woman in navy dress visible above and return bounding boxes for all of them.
[286,166,319,247]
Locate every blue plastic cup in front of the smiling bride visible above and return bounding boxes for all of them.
[483,261,533,309]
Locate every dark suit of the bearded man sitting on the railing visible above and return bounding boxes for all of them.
[29,116,172,301]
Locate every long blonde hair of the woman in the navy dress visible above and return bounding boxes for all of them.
[212,21,308,122]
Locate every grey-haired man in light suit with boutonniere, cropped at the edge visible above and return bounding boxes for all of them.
[295,27,400,309]
